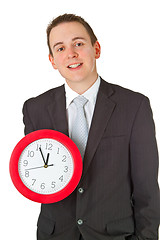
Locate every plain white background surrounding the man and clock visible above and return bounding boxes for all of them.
[0,0,160,240]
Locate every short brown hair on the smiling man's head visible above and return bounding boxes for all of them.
[46,14,97,55]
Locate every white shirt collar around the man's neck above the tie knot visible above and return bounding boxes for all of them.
[64,76,100,109]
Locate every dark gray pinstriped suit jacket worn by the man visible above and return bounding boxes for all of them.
[23,79,160,240]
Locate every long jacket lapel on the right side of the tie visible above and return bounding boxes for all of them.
[82,79,115,178]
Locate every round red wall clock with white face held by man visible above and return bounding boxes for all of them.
[10,129,83,203]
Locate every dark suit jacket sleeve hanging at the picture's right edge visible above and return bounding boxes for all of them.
[130,97,160,239]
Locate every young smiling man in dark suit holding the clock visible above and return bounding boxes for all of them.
[23,14,160,240]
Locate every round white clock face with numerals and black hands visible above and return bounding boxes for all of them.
[18,138,74,194]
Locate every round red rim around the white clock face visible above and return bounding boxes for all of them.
[9,129,83,203]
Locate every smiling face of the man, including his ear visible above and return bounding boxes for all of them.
[49,22,100,87]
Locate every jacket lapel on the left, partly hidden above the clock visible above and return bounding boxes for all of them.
[48,85,68,135]
